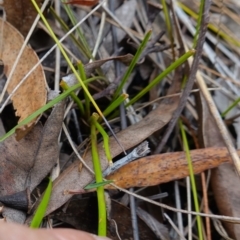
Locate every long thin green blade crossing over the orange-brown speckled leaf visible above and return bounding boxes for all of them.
[179,120,203,240]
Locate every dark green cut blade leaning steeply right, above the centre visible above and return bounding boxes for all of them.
[113,30,152,100]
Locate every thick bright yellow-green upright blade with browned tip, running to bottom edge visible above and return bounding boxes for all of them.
[90,115,107,236]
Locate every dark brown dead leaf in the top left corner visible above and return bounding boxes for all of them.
[2,0,43,37]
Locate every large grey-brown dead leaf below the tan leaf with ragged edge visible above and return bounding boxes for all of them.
[0,101,65,222]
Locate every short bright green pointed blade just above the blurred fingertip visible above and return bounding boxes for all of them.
[30,178,52,228]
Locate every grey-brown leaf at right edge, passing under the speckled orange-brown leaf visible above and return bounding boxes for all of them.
[198,91,240,239]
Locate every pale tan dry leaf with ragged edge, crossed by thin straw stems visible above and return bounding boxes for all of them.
[0,19,47,139]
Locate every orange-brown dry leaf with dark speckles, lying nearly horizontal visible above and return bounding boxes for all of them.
[106,148,231,189]
